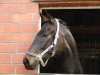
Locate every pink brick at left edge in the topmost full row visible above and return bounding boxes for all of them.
[0,4,18,13]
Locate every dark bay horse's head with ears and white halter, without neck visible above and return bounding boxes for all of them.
[23,13,63,70]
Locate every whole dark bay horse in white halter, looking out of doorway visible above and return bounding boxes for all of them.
[23,13,82,74]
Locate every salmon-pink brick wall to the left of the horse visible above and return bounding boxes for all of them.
[0,0,39,75]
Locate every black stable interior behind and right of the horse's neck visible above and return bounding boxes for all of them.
[43,9,100,74]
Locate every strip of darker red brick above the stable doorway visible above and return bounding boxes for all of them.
[36,0,100,7]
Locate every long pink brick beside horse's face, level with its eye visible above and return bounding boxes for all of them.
[12,33,34,43]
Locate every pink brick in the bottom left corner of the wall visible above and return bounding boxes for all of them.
[0,64,15,74]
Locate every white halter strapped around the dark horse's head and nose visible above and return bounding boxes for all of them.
[26,19,59,67]
